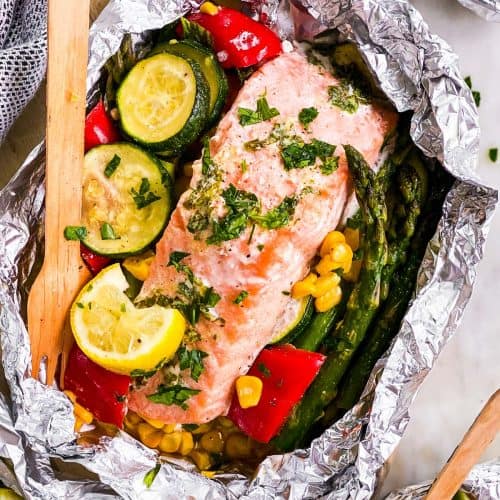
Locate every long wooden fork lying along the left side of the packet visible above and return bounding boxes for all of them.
[28,0,89,384]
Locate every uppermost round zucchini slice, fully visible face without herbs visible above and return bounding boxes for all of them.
[116,52,210,155]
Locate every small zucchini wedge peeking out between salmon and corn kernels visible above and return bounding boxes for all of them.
[270,297,314,344]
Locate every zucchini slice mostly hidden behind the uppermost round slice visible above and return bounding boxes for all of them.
[150,40,229,127]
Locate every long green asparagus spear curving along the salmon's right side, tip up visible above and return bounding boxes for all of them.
[274,145,387,451]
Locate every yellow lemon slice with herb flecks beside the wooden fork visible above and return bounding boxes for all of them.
[71,264,186,374]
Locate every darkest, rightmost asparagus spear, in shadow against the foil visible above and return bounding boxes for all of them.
[334,166,451,412]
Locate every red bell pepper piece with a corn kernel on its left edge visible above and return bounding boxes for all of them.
[228,344,326,443]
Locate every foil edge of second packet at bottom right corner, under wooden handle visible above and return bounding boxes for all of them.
[385,461,500,500]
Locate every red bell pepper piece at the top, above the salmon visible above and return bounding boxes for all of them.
[187,7,282,68]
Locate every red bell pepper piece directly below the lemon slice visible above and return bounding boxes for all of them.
[64,344,132,428]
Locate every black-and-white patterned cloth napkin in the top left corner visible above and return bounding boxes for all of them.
[0,0,47,145]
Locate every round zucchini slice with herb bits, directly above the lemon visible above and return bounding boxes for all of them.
[82,143,172,257]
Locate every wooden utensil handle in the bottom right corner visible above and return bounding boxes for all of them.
[425,389,500,500]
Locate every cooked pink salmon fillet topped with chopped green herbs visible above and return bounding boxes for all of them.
[129,52,397,423]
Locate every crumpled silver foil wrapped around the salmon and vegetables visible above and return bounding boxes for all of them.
[0,0,497,499]
